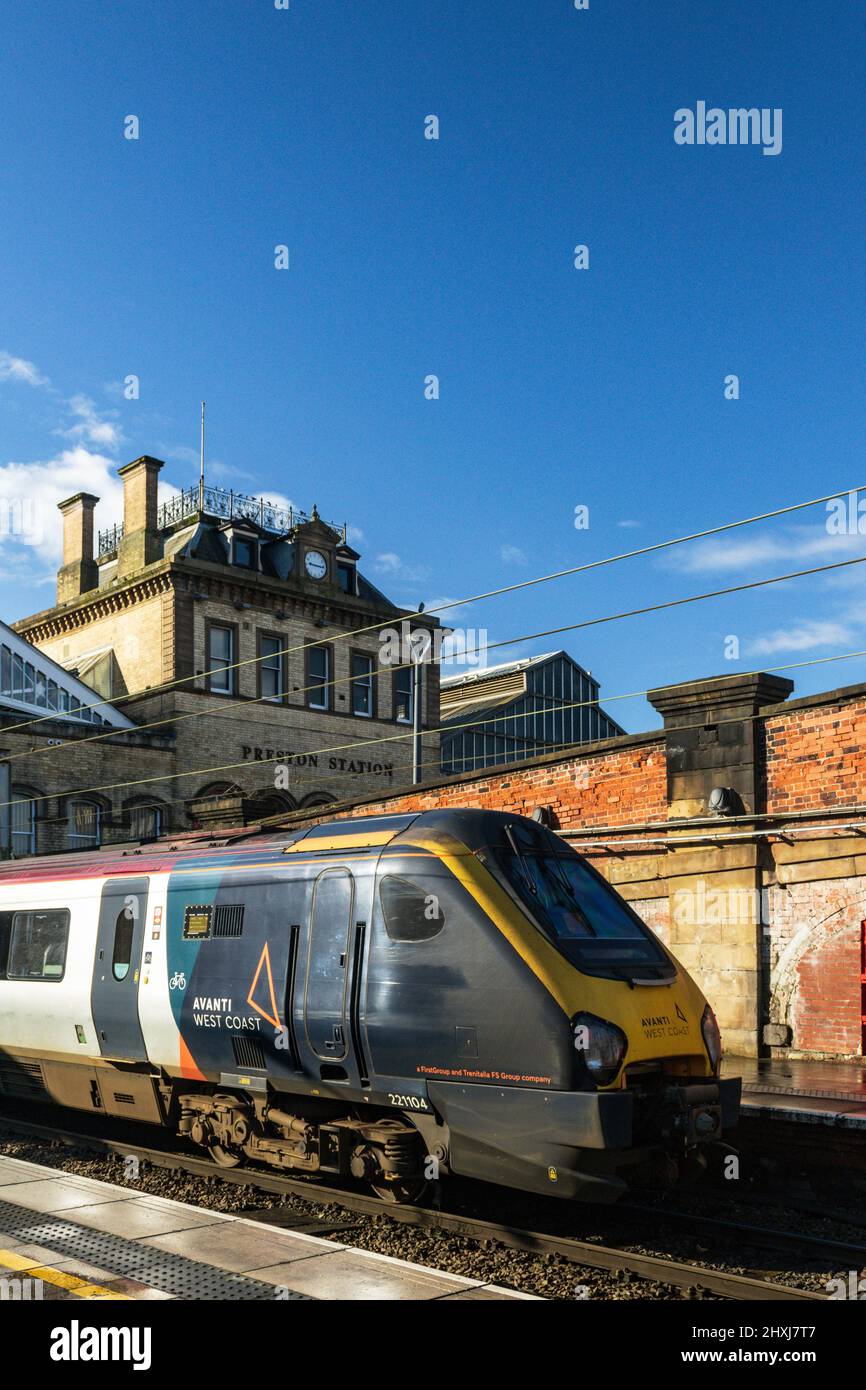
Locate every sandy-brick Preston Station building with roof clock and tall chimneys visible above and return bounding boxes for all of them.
[6,456,439,848]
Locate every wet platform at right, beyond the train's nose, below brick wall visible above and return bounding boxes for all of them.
[723,1056,866,1133]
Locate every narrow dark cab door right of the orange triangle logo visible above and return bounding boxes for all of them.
[303,869,368,1084]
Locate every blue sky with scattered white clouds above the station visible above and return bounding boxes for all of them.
[0,0,866,728]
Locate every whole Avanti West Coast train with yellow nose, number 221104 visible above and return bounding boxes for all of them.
[0,809,740,1202]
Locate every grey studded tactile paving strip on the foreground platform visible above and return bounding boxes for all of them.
[0,1201,314,1302]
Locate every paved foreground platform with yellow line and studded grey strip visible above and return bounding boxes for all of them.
[0,1156,532,1301]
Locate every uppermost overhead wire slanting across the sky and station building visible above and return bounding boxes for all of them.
[6,484,863,733]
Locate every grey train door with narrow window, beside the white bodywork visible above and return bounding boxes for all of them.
[90,878,147,1062]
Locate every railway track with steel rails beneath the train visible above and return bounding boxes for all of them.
[0,1112,866,1301]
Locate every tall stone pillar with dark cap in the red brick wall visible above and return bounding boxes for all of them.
[648,673,794,1056]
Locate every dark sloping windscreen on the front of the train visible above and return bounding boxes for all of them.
[495,826,673,979]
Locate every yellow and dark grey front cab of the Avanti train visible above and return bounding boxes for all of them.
[366,812,740,1201]
